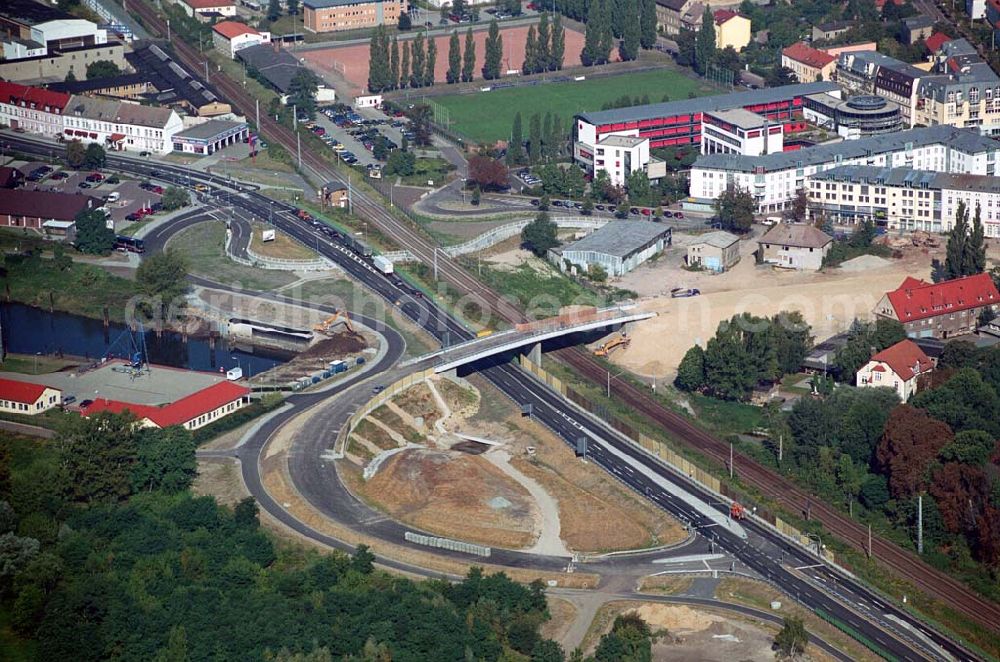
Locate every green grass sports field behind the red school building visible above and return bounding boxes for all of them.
[434,69,718,142]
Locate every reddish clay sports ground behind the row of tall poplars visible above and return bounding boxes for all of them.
[300,25,588,94]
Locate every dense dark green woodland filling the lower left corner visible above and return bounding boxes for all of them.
[0,414,564,662]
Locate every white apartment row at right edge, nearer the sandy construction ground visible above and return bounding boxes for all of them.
[807,165,1000,238]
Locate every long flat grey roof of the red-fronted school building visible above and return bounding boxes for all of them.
[576,82,840,124]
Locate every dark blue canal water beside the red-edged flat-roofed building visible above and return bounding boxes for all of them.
[0,303,293,376]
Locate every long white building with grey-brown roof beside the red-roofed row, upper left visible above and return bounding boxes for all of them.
[63,96,184,154]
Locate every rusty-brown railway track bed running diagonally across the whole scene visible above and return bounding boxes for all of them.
[132,2,1000,632]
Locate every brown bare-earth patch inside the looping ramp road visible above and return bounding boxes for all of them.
[362,449,536,548]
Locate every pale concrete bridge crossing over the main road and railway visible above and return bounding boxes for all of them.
[414,305,656,373]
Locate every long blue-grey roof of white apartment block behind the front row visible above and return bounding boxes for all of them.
[694,124,1000,172]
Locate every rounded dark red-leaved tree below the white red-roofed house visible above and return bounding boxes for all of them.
[875,405,952,499]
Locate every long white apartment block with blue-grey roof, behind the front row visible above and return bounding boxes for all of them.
[690,126,1000,213]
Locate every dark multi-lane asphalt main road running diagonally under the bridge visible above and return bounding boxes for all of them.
[0,132,974,660]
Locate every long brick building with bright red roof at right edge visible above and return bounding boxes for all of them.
[874,274,1000,338]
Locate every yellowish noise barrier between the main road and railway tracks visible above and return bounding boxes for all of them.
[518,356,836,563]
